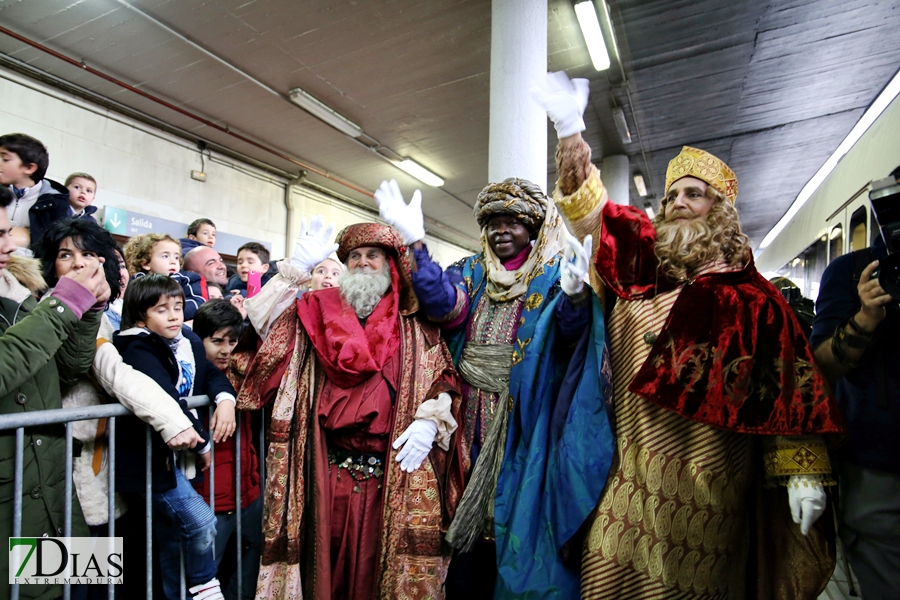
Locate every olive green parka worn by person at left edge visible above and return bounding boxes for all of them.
[0,263,102,600]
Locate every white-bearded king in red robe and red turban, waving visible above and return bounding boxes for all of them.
[232,218,462,600]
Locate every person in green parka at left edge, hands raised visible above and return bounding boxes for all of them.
[0,186,109,599]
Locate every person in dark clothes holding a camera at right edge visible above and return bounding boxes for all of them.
[810,167,900,600]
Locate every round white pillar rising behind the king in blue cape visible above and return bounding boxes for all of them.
[488,0,548,192]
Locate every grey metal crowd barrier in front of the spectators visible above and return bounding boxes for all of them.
[0,396,266,600]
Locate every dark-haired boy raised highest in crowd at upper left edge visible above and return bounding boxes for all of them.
[0,133,69,250]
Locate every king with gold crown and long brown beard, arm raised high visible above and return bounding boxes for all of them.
[534,73,843,600]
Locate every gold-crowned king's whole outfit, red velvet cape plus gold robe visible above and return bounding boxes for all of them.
[557,168,843,599]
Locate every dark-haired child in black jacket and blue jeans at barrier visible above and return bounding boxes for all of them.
[113,273,235,600]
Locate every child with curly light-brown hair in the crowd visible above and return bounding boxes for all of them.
[125,233,209,321]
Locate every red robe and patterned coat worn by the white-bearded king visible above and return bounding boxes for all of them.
[234,261,462,600]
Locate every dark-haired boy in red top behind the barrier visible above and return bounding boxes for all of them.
[193,299,262,599]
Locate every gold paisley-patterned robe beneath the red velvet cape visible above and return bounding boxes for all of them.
[557,153,834,600]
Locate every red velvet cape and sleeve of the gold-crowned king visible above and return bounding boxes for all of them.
[596,202,844,435]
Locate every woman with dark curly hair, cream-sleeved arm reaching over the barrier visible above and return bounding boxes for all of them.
[35,219,206,595]
